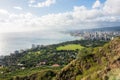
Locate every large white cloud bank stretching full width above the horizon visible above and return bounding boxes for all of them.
[0,0,120,32]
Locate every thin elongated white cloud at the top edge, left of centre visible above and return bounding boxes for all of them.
[29,0,56,8]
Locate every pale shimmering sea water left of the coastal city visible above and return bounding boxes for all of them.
[0,31,75,55]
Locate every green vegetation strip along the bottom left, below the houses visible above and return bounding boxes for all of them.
[0,66,62,80]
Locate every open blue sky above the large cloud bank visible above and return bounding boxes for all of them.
[0,0,105,16]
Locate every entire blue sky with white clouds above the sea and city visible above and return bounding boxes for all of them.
[0,0,120,33]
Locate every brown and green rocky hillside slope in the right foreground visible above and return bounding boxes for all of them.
[56,37,120,80]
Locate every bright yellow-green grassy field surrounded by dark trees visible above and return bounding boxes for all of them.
[56,44,84,50]
